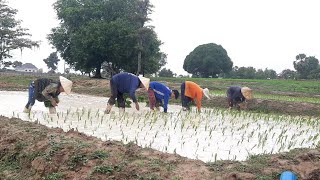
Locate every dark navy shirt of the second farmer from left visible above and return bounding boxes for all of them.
[111,72,140,102]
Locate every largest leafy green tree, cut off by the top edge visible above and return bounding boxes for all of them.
[48,0,163,78]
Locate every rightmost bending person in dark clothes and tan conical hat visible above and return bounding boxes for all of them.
[227,86,253,110]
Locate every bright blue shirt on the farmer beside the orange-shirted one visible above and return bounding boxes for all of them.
[149,81,172,112]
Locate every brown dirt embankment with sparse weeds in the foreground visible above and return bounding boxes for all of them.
[0,116,320,180]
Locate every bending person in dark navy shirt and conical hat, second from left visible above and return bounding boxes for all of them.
[105,72,150,114]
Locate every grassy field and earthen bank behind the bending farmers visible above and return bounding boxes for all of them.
[0,75,320,116]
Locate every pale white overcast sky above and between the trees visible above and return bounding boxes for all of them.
[9,0,320,74]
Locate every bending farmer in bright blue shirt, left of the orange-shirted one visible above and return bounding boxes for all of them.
[148,82,179,113]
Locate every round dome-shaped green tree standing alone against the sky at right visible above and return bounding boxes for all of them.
[183,43,233,77]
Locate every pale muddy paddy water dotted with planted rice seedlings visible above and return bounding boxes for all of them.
[0,91,320,162]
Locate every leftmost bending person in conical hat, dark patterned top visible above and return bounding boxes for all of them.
[23,76,72,114]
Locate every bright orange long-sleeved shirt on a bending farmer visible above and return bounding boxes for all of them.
[184,81,203,110]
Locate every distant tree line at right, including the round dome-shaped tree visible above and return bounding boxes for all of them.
[166,43,320,79]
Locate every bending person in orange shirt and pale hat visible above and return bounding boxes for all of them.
[181,81,210,112]
